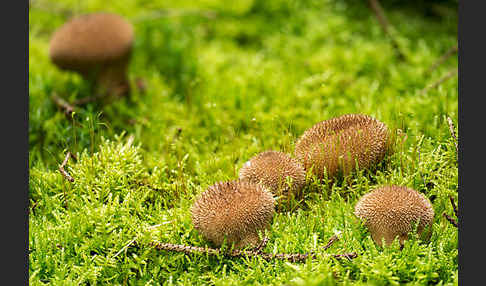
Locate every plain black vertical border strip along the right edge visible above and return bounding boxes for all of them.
[458,0,486,285]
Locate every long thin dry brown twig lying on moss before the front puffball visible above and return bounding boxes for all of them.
[150,241,358,262]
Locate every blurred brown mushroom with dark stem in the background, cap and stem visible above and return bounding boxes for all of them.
[49,13,134,98]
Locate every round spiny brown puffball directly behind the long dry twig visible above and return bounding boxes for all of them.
[191,181,275,249]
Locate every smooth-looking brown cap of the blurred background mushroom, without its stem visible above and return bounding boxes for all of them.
[49,13,133,75]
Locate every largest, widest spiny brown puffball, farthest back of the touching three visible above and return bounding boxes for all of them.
[295,114,390,179]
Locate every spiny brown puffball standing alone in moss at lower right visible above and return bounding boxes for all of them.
[354,186,434,246]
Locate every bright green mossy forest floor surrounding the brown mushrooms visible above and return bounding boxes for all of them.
[29,0,458,285]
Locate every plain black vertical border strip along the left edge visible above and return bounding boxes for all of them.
[8,1,29,285]
